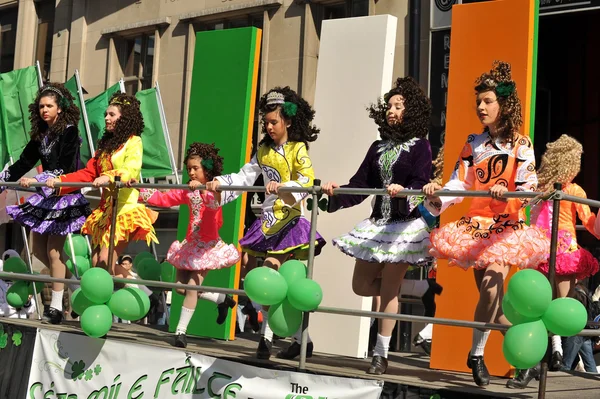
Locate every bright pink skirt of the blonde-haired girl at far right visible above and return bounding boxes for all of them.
[538,230,598,280]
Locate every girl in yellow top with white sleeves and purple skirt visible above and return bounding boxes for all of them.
[206,87,325,359]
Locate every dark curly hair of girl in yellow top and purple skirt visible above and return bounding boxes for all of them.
[258,86,320,148]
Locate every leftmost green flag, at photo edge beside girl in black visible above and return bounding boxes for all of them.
[0,66,39,169]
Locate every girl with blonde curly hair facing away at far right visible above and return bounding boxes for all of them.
[531,134,600,371]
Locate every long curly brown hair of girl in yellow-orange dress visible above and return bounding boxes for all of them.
[96,93,144,158]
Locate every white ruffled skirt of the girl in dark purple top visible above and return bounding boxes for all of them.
[333,218,432,266]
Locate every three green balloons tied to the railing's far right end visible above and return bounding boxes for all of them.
[502,269,588,369]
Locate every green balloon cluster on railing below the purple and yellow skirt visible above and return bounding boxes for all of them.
[244,260,323,337]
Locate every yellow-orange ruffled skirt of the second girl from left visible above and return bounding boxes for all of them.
[81,205,158,248]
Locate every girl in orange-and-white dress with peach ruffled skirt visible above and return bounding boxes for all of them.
[423,61,549,386]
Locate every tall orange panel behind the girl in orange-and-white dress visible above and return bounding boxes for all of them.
[431,0,537,376]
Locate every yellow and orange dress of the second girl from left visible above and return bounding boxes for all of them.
[59,136,158,247]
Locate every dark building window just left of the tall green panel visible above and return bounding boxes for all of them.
[119,34,155,95]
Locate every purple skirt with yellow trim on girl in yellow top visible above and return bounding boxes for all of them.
[240,217,325,260]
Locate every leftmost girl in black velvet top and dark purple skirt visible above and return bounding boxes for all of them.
[0,83,91,324]
